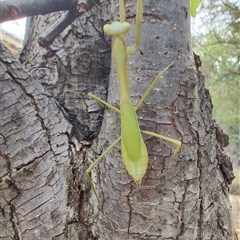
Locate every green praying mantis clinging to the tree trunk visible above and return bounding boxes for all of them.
[86,0,181,203]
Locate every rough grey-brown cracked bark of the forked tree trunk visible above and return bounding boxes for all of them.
[0,0,234,240]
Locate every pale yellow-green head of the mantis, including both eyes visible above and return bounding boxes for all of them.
[103,22,130,36]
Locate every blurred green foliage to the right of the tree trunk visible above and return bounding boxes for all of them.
[193,0,240,163]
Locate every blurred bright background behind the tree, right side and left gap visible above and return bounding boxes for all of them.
[0,0,240,236]
